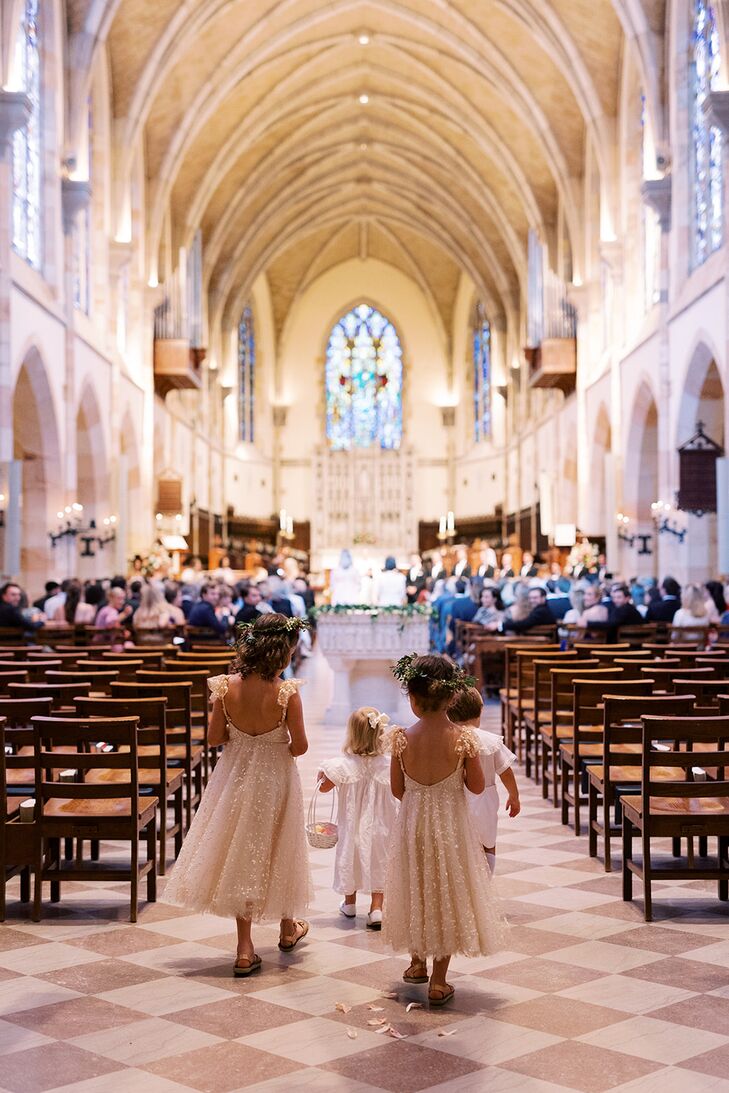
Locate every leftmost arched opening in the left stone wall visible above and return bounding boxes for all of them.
[13,349,66,596]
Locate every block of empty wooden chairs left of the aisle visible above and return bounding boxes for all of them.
[0,642,231,920]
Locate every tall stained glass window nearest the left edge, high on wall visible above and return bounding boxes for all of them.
[13,0,40,269]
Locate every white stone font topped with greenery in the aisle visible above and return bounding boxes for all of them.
[317,608,430,728]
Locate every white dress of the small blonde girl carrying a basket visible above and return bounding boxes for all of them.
[321,755,397,895]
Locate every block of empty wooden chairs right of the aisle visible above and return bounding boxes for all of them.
[501,643,729,920]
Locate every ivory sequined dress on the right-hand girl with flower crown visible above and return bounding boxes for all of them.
[383,729,506,960]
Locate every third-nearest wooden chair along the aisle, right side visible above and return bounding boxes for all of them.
[560,677,652,835]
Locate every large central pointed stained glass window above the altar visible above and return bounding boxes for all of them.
[326,304,402,450]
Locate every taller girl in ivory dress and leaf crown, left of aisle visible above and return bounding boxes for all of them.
[164,613,311,976]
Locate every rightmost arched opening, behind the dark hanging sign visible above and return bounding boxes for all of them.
[673,342,725,580]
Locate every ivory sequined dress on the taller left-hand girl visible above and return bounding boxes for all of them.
[164,675,311,921]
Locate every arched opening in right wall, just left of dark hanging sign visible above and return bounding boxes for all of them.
[622,383,659,576]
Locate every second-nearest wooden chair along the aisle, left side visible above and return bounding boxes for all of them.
[75,697,185,877]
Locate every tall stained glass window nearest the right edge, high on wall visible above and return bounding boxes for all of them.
[691,0,724,267]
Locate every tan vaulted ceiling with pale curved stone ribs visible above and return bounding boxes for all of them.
[67,0,665,325]
